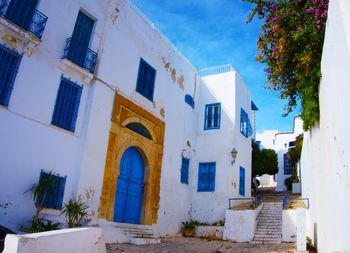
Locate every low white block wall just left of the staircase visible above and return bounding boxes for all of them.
[223,205,263,242]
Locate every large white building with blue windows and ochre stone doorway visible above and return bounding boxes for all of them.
[0,0,254,242]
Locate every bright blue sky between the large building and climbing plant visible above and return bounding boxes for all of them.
[134,0,297,132]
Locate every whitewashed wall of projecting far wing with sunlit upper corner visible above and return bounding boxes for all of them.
[192,71,252,222]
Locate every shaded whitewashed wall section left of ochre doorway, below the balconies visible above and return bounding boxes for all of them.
[0,1,110,230]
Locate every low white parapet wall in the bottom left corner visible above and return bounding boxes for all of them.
[3,228,106,253]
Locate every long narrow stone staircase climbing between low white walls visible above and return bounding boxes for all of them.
[254,202,282,244]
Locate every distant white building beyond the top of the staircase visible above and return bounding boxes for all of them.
[256,117,303,191]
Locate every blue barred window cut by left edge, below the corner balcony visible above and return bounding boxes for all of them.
[0,45,22,106]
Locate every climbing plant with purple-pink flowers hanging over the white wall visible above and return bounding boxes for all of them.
[243,0,329,130]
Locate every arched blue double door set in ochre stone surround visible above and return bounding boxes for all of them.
[114,147,144,224]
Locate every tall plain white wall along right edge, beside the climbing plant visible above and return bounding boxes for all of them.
[301,0,350,253]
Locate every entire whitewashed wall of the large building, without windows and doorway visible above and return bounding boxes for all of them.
[0,0,252,235]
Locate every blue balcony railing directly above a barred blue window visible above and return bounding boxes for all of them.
[63,38,97,73]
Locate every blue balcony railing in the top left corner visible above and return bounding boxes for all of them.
[0,0,47,39]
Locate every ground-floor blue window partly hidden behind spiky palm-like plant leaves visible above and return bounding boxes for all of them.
[39,171,67,209]
